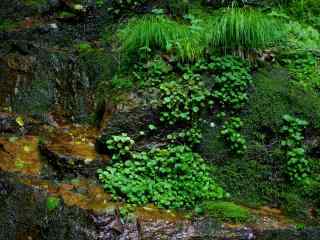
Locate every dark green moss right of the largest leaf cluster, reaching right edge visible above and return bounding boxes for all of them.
[215,159,320,224]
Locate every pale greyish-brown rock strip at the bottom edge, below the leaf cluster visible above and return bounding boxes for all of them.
[92,207,255,240]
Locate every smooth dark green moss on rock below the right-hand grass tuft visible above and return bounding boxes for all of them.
[244,69,320,132]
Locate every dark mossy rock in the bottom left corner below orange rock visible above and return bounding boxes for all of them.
[0,171,98,240]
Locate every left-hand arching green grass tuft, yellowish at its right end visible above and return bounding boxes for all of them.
[119,16,205,61]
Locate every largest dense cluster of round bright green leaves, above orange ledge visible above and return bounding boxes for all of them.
[98,145,225,209]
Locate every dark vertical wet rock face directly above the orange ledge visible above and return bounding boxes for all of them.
[0,40,101,121]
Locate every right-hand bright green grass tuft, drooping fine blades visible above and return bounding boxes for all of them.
[208,7,280,53]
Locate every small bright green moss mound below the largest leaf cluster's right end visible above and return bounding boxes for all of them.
[203,201,250,223]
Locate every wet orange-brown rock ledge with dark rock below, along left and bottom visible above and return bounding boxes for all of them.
[0,122,319,240]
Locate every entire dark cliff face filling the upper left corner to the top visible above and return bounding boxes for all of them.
[0,0,112,121]
